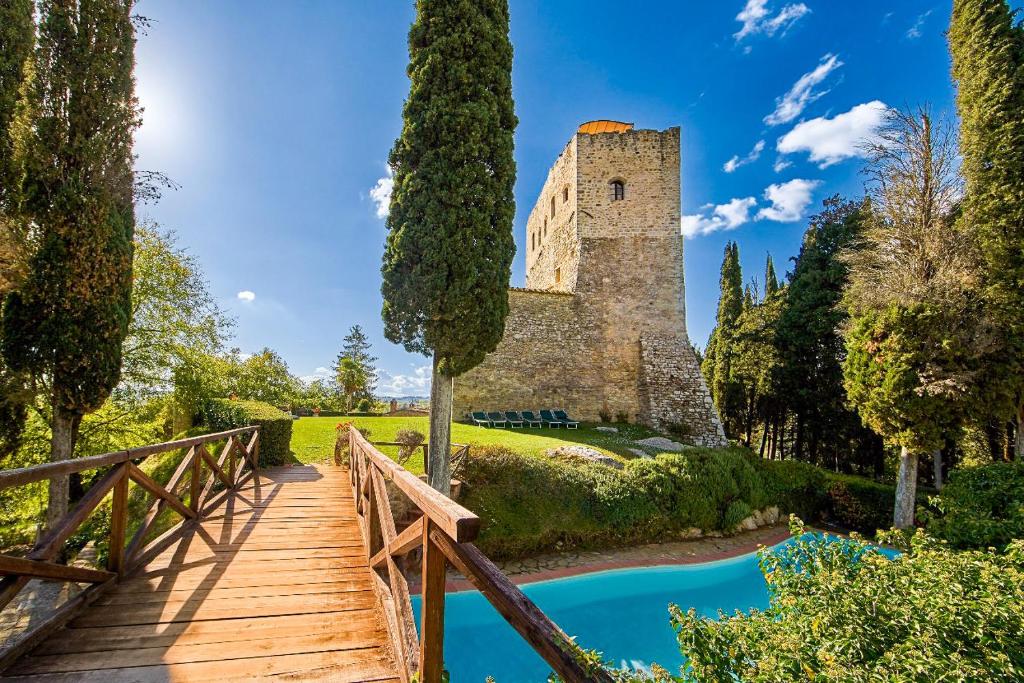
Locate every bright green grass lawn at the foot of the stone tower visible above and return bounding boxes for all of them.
[292,417,671,474]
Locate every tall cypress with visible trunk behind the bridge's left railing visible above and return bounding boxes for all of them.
[3,0,138,525]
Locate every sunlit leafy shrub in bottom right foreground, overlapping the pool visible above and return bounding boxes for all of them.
[670,525,1024,683]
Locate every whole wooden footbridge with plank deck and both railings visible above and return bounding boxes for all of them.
[0,427,610,683]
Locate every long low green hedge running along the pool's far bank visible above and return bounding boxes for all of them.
[463,446,894,559]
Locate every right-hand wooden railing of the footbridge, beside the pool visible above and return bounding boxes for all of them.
[349,428,611,683]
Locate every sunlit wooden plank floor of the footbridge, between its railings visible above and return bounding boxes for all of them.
[3,467,398,683]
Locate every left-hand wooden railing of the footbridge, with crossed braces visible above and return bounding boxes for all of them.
[0,426,259,671]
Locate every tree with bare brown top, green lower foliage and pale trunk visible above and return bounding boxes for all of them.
[843,110,979,527]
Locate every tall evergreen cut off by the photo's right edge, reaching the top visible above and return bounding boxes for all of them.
[948,0,1024,458]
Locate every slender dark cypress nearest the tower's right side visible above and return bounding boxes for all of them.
[701,242,744,435]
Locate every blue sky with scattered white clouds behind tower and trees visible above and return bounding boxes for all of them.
[130,0,991,395]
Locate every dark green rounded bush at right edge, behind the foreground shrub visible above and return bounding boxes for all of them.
[921,460,1024,549]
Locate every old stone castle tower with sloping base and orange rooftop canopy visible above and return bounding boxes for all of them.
[453,121,726,445]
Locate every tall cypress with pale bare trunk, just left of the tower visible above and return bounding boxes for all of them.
[381,0,517,494]
